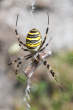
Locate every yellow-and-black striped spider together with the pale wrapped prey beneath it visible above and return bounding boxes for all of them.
[9,15,61,85]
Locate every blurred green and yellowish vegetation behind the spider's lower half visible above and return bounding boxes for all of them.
[10,51,73,110]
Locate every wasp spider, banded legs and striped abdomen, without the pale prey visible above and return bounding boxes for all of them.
[9,15,55,81]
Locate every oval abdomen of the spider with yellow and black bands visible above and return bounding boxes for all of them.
[26,29,42,51]
